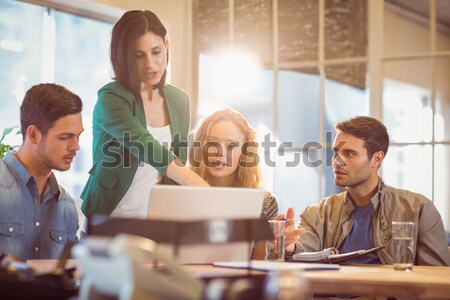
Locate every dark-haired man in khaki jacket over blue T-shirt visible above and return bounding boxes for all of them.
[295,117,450,266]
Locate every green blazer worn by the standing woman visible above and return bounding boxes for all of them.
[81,81,190,216]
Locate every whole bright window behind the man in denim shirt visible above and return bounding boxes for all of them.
[0,0,112,202]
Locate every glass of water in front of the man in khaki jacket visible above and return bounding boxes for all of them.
[392,222,414,271]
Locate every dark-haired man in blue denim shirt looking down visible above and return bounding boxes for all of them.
[0,83,83,260]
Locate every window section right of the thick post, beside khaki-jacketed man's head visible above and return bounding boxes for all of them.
[382,0,450,225]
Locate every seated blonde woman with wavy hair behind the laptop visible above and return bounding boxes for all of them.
[189,109,282,259]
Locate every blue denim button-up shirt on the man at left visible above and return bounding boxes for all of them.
[0,152,78,261]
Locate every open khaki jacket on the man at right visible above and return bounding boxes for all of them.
[295,179,450,266]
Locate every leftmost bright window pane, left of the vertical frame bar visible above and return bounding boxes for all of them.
[0,0,46,128]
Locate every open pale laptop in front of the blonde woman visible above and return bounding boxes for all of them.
[147,185,264,264]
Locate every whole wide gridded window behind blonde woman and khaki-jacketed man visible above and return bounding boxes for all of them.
[194,0,450,226]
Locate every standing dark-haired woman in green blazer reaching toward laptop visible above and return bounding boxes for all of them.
[81,10,208,224]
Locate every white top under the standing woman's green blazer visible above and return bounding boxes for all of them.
[111,125,172,219]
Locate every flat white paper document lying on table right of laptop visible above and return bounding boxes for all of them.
[214,260,340,271]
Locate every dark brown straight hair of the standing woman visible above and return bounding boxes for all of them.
[110,10,169,101]
